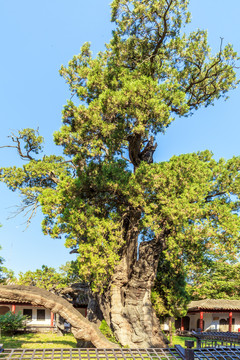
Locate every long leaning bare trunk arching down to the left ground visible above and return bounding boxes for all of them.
[0,285,118,348]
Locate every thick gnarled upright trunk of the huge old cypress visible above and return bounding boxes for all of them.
[98,213,165,348]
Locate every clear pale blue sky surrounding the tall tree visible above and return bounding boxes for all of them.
[0,0,240,274]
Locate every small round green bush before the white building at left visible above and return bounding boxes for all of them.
[0,311,27,335]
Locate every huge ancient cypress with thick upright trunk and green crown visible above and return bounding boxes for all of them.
[1,0,240,347]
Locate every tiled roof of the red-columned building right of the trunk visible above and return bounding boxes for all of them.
[188,299,240,311]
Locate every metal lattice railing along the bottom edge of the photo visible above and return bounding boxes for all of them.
[0,345,240,360]
